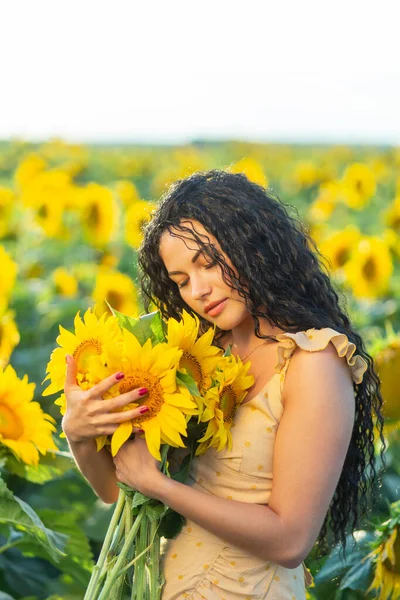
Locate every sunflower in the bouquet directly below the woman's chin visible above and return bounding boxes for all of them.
[167,309,222,395]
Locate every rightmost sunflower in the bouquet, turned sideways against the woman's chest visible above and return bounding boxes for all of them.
[196,355,254,456]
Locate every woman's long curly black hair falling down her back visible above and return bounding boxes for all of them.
[139,170,386,560]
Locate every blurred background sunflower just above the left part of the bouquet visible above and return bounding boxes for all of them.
[93,269,138,317]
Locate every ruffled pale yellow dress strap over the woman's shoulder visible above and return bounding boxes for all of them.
[275,327,368,384]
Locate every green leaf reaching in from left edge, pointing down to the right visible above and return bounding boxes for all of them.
[0,479,66,562]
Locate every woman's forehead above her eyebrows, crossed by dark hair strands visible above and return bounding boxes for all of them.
[160,221,218,262]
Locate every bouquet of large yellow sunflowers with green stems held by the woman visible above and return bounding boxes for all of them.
[44,307,253,600]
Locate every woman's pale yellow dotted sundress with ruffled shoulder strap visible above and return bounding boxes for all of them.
[161,328,367,600]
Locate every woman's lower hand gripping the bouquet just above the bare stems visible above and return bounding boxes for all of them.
[113,435,166,498]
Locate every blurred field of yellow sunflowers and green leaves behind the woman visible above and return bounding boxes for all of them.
[0,139,400,600]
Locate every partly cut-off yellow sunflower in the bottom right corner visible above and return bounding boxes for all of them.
[367,525,400,600]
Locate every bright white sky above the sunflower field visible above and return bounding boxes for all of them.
[0,0,400,145]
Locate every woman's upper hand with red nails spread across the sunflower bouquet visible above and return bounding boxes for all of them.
[62,356,148,442]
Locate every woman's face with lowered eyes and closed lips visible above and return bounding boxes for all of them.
[160,220,252,331]
